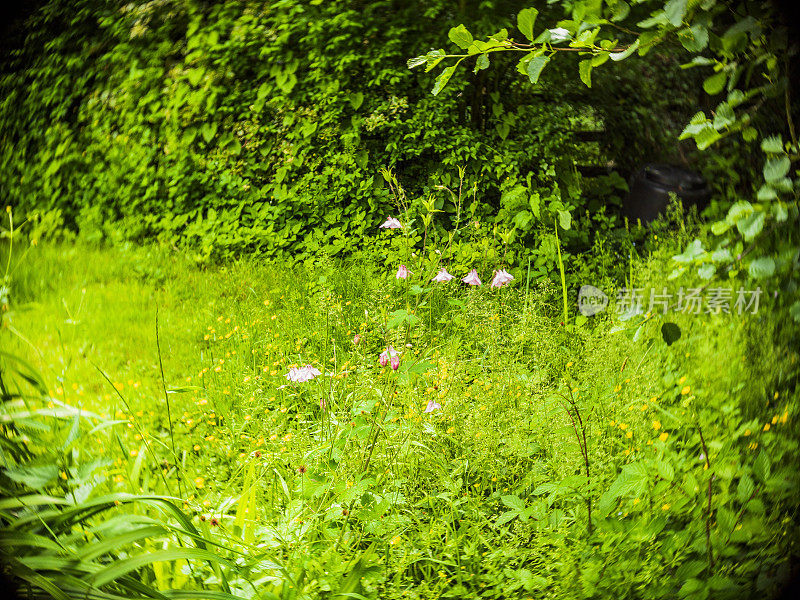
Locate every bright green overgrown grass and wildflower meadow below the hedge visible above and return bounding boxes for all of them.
[0,240,800,598]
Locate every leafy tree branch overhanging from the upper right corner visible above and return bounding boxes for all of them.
[408,0,800,321]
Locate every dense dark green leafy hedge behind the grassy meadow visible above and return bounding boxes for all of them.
[0,0,683,260]
